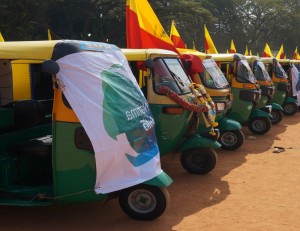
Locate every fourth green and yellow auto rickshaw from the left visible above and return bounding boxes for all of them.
[212,53,272,134]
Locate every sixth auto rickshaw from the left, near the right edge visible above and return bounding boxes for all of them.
[261,57,298,115]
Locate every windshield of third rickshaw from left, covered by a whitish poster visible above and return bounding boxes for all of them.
[201,59,229,89]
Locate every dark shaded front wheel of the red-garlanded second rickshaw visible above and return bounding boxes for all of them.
[180,148,218,175]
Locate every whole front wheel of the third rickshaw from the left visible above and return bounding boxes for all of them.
[218,130,245,150]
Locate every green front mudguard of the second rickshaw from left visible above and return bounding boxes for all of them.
[178,134,221,152]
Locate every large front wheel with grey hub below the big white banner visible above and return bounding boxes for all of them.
[119,184,170,221]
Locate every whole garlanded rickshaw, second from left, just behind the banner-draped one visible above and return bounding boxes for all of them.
[122,49,221,174]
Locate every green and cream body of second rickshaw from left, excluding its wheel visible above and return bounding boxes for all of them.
[122,49,220,153]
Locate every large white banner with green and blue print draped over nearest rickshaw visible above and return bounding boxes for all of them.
[57,50,162,193]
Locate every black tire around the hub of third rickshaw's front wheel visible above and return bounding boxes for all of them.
[218,130,245,150]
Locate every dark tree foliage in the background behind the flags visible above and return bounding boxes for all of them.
[0,0,300,56]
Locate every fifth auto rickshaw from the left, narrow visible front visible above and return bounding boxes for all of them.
[246,56,283,124]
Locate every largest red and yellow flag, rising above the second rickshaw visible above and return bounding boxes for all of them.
[126,0,178,53]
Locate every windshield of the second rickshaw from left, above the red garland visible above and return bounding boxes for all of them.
[154,58,191,95]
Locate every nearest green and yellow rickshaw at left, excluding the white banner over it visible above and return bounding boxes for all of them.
[0,40,172,220]
